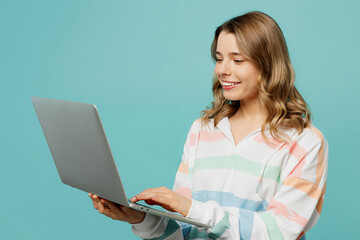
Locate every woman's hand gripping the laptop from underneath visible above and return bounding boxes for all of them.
[89,193,145,224]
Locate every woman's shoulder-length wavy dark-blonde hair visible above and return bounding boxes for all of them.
[201,12,311,141]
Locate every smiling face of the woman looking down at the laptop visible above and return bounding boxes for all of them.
[215,31,260,101]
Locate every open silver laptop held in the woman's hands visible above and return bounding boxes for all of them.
[31,97,210,228]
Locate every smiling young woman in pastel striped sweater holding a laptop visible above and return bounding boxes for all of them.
[89,12,328,239]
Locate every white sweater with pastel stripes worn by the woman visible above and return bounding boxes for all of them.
[132,118,328,240]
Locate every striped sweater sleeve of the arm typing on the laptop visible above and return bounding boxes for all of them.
[188,128,328,240]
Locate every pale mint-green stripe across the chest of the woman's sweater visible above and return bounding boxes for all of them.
[191,155,280,181]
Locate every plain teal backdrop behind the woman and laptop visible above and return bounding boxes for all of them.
[0,0,360,240]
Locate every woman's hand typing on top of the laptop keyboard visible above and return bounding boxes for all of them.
[131,187,191,216]
